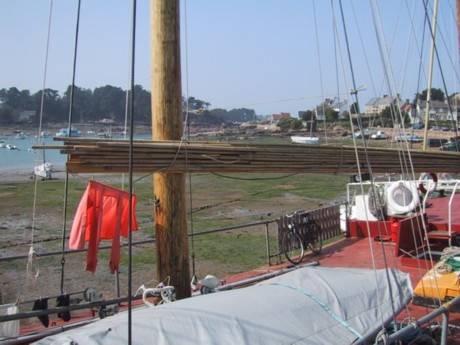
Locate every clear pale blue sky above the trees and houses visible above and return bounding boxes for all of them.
[0,0,459,116]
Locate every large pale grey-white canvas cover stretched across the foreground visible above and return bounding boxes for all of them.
[34,267,412,345]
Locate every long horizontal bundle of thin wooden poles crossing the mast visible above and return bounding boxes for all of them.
[34,137,460,174]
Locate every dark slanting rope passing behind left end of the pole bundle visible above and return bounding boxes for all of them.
[61,0,81,293]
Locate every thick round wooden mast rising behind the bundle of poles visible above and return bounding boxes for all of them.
[150,0,191,298]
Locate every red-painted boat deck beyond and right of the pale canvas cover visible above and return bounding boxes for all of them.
[230,194,460,345]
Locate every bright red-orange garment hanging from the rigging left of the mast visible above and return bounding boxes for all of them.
[69,181,138,273]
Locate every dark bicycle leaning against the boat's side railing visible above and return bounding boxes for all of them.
[281,212,323,265]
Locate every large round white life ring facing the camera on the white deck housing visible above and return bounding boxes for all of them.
[386,180,420,214]
